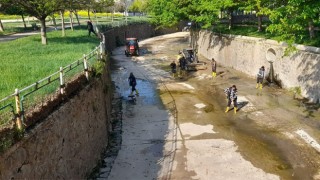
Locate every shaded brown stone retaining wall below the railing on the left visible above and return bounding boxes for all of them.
[0,63,112,179]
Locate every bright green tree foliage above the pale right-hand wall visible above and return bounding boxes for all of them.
[146,0,320,47]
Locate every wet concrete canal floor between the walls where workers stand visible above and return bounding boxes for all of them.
[93,32,320,180]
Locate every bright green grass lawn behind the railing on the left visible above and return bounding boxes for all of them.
[0,26,99,99]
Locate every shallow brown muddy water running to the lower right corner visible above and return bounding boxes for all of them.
[163,82,314,179]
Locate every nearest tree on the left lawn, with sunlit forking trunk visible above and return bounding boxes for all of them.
[8,0,64,45]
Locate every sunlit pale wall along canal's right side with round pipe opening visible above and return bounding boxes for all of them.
[194,31,320,102]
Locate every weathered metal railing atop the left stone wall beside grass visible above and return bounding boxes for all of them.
[0,42,105,129]
